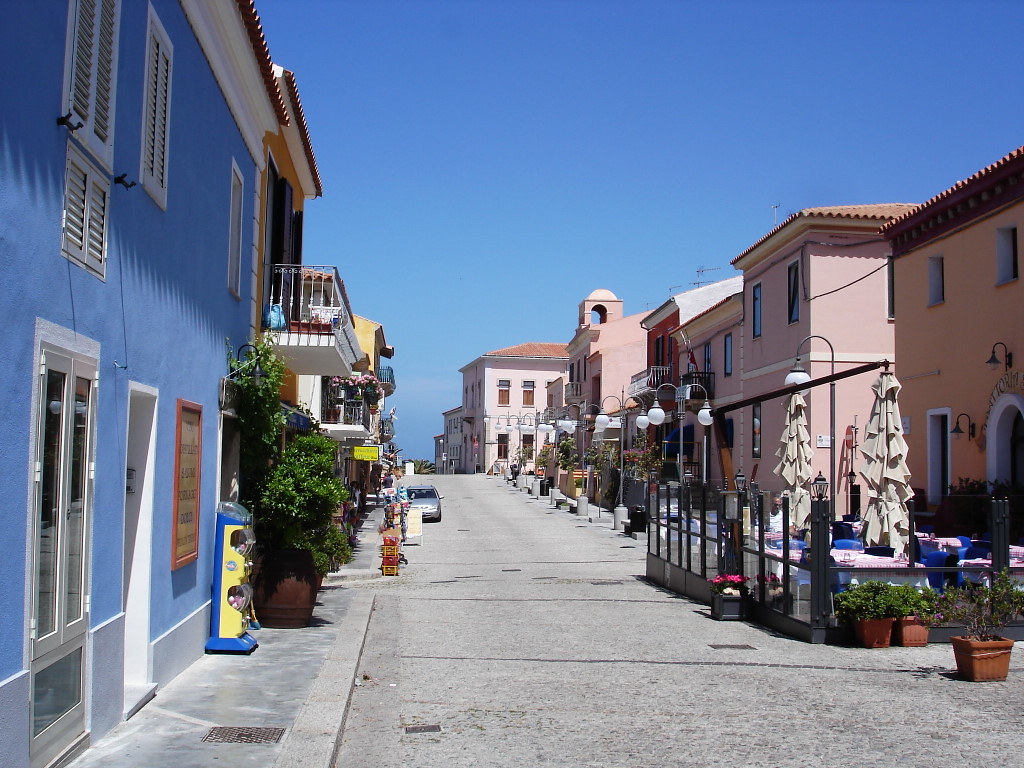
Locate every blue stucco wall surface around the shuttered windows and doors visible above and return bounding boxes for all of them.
[0,0,257,692]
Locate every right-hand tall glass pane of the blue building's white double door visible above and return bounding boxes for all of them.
[65,377,92,624]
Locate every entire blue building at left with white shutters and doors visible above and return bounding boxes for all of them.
[0,0,287,768]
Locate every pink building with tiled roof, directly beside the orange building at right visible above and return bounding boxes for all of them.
[679,204,912,513]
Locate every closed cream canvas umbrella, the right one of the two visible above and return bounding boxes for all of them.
[860,371,913,552]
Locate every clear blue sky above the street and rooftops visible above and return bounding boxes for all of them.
[256,0,1024,459]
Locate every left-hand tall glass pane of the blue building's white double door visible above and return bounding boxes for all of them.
[36,370,67,638]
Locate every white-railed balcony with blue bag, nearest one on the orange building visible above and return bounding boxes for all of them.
[263,264,362,376]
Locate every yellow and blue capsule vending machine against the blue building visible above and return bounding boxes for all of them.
[206,502,258,653]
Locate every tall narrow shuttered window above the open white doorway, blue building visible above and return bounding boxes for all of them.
[139,8,174,208]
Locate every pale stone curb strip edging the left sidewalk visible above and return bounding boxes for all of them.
[273,590,374,768]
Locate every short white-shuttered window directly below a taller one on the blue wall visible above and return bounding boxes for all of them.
[61,146,111,278]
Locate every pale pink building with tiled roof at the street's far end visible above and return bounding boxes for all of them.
[452,342,568,473]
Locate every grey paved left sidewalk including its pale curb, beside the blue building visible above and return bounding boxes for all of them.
[70,508,382,768]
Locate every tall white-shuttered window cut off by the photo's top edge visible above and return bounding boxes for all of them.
[65,0,121,165]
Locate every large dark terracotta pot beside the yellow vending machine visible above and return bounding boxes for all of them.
[251,549,319,629]
